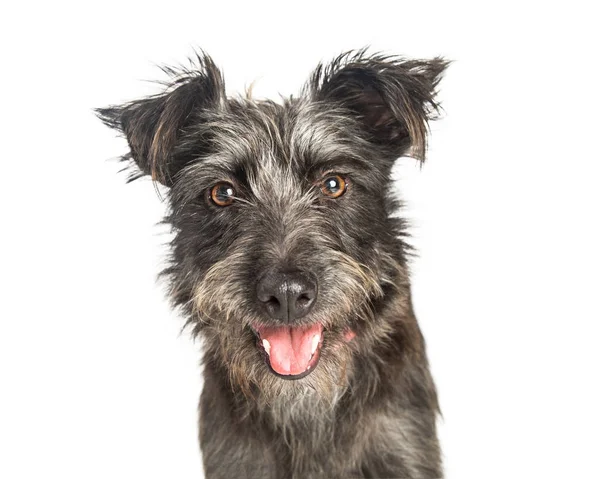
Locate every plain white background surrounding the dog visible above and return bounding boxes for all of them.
[0,1,600,479]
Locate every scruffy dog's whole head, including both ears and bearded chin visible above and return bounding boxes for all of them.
[98,51,446,399]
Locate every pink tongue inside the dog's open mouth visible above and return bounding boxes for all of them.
[257,324,323,375]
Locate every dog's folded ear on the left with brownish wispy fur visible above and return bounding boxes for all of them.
[96,54,225,186]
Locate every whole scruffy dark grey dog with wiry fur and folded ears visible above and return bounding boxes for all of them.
[98,50,447,479]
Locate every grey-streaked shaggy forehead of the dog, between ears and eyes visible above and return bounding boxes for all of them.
[174,98,373,202]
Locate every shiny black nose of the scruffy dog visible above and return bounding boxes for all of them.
[257,271,317,323]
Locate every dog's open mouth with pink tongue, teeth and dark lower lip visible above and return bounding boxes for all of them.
[252,323,323,379]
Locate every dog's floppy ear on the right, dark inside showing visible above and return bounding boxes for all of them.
[308,50,449,160]
